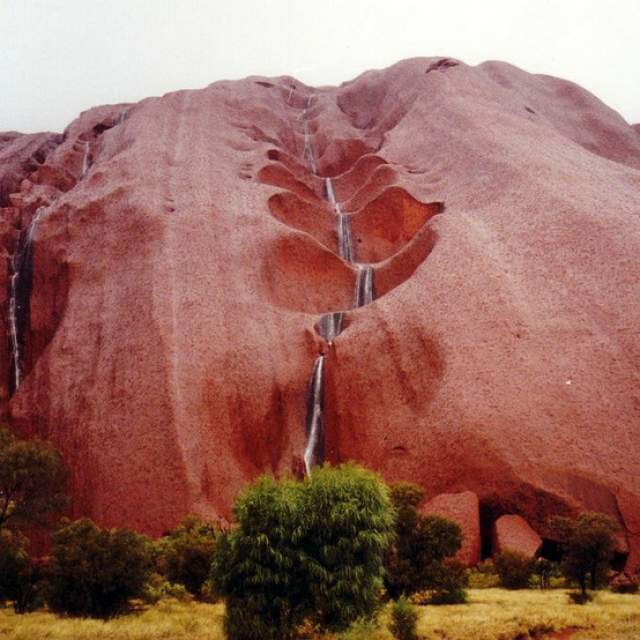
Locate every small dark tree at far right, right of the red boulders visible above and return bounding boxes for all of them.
[551,512,617,599]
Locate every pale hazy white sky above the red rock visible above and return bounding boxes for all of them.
[0,0,640,132]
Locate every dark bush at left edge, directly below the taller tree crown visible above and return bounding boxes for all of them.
[0,531,42,613]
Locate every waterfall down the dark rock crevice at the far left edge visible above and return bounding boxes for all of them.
[9,207,44,392]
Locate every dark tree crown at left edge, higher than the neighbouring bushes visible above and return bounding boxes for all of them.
[0,427,67,529]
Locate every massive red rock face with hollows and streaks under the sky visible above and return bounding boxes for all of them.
[0,58,640,566]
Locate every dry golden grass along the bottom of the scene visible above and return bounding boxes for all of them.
[0,589,640,640]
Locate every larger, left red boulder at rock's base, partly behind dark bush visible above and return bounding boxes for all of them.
[420,491,481,567]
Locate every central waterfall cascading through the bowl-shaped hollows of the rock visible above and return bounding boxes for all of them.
[300,95,374,476]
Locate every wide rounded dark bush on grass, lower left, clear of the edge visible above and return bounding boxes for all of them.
[47,518,151,619]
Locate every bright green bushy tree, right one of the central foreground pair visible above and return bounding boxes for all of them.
[298,464,394,631]
